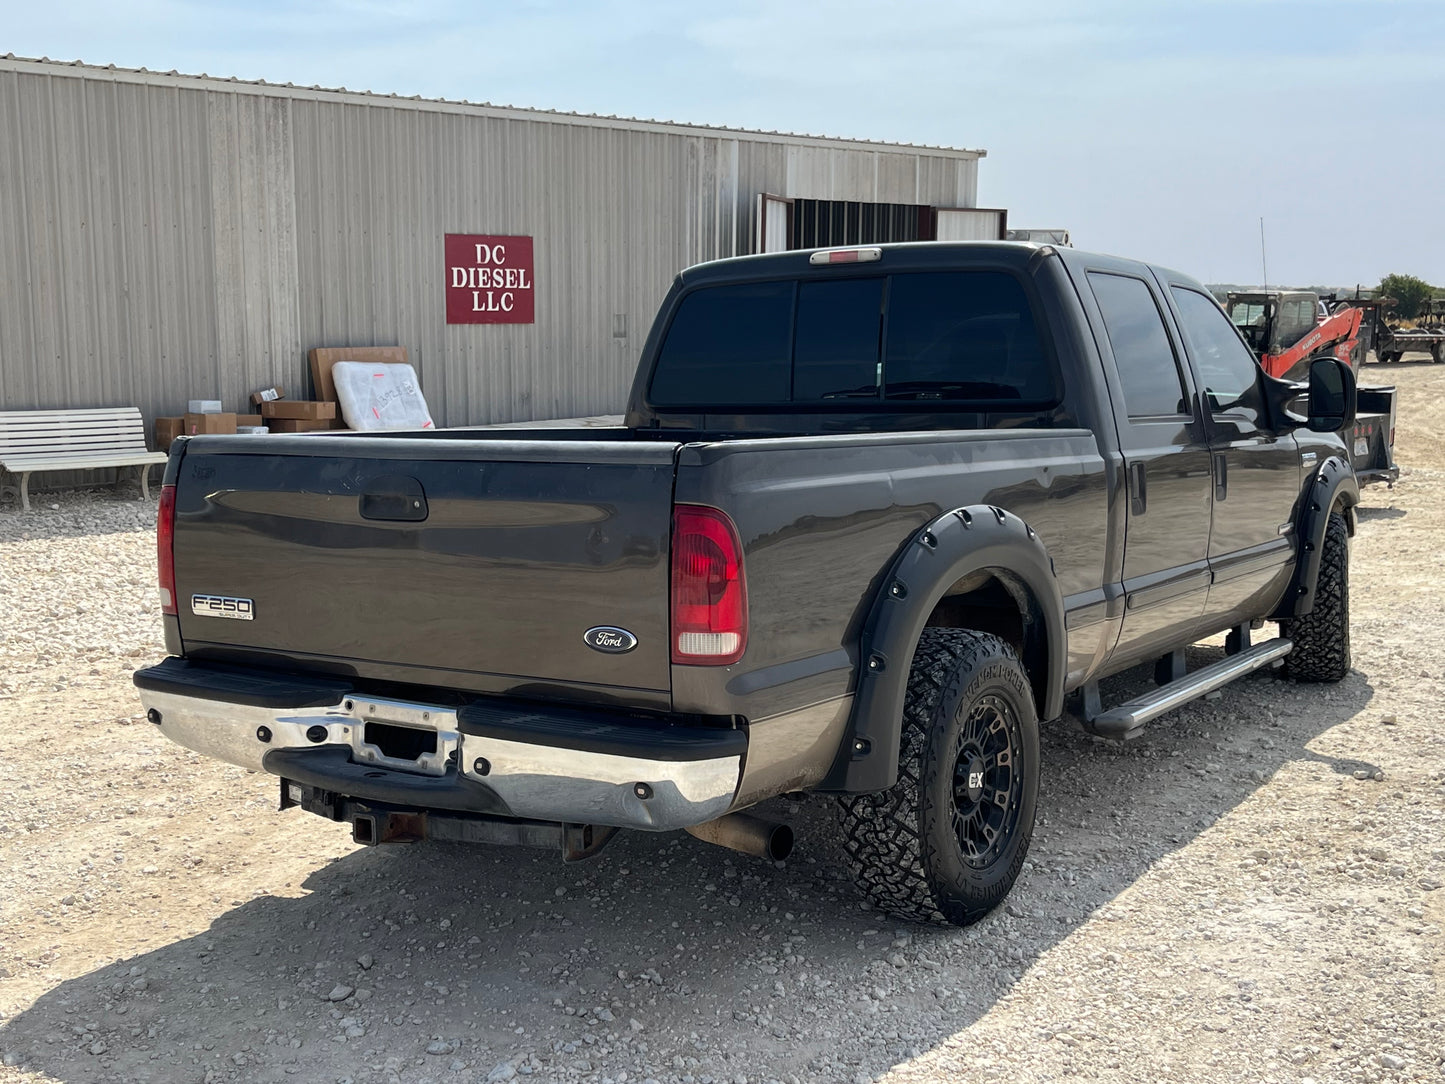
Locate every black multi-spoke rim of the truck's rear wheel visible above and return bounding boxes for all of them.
[952,697,1023,869]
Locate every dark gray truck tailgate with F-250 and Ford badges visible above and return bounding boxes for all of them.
[175,434,676,707]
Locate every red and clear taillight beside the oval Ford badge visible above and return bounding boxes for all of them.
[672,504,747,666]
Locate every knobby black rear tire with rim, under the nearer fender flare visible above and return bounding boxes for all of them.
[841,629,1039,926]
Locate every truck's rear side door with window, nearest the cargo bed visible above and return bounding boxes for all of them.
[1081,262,1211,661]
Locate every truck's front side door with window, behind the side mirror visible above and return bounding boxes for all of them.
[1169,283,1301,635]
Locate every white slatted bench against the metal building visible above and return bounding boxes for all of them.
[0,406,166,512]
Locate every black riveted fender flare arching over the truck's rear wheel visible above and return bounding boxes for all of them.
[819,504,1068,793]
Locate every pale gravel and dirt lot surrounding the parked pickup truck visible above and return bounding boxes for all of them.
[0,364,1445,1084]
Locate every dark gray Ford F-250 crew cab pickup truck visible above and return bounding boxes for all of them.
[136,243,1358,924]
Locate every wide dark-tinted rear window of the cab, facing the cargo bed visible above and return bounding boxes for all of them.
[649,270,1062,410]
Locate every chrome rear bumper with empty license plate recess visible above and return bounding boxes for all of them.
[136,663,746,831]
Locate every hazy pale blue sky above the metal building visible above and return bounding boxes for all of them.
[11,0,1445,285]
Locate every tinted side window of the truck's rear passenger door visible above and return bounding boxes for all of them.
[1088,272,1192,418]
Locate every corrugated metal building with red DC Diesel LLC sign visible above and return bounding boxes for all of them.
[0,55,1004,425]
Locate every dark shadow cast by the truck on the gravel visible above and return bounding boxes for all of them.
[0,648,1374,1084]
